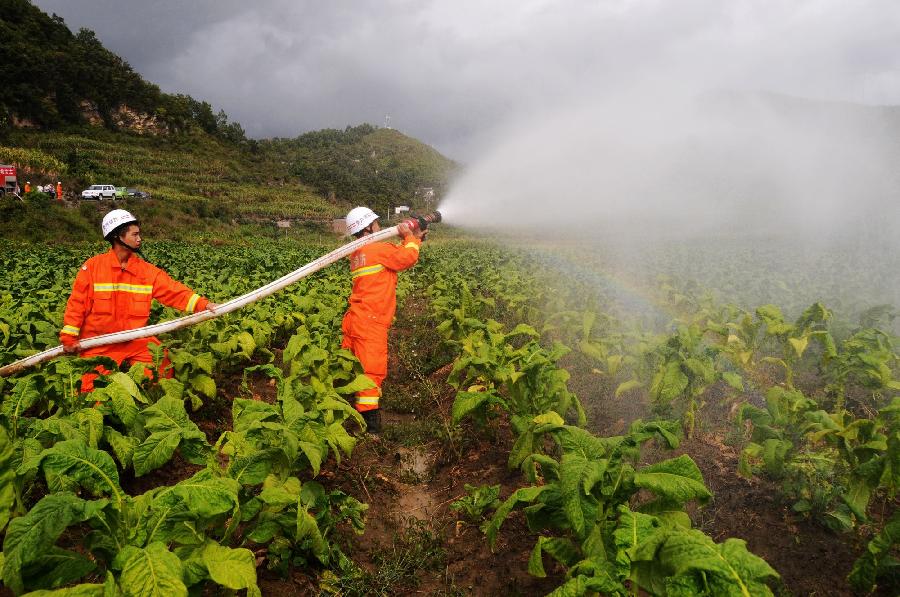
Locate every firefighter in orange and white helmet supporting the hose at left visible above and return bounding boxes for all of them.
[59,209,217,392]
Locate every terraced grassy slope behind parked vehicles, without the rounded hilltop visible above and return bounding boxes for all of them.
[0,127,347,241]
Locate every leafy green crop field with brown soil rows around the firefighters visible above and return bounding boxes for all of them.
[0,231,900,596]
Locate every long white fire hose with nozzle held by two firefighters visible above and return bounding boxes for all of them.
[0,211,441,377]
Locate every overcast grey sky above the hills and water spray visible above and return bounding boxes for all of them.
[34,0,900,160]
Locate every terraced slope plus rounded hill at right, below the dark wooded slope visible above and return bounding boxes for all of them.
[0,125,452,241]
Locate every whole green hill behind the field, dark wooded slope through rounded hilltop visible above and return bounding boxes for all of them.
[0,0,456,241]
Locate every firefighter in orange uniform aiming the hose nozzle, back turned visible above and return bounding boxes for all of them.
[341,207,424,433]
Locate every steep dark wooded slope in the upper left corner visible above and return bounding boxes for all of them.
[0,0,244,141]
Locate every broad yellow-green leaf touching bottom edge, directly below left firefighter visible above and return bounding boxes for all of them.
[112,542,187,597]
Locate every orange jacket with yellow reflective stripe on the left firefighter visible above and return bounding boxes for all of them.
[59,249,209,366]
